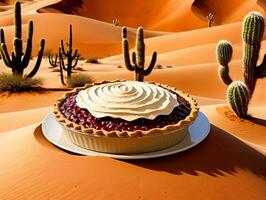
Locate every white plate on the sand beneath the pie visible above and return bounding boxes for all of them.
[42,112,210,160]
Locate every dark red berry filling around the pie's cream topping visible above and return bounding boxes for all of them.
[60,93,191,131]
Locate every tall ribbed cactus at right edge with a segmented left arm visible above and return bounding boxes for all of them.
[216,12,266,118]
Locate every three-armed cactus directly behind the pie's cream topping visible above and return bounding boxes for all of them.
[122,27,157,81]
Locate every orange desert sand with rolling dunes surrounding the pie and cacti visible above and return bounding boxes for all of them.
[0,0,266,200]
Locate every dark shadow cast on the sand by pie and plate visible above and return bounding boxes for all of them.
[34,125,266,178]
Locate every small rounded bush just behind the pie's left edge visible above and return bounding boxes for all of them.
[67,73,93,88]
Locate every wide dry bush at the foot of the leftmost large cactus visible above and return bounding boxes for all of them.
[0,72,42,92]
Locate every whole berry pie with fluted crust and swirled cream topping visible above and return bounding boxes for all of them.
[54,81,198,154]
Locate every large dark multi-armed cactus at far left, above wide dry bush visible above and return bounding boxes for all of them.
[0,1,45,78]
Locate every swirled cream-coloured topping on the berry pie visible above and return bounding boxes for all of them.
[76,81,179,121]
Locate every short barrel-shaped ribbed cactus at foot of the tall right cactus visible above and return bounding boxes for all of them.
[227,81,250,118]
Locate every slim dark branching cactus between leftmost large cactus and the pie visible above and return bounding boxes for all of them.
[59,24,79,78]
